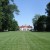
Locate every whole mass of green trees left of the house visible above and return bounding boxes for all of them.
[0,0,19,31]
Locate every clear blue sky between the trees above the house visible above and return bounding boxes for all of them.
[14,0,50,26]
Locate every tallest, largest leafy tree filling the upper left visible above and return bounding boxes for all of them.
[0,0,19,31]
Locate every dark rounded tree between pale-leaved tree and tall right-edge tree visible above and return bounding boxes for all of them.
[37,15,46,31]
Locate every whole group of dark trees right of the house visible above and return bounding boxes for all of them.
[32,2,50,31]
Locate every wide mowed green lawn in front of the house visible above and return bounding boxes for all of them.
[0,31,50,50]
